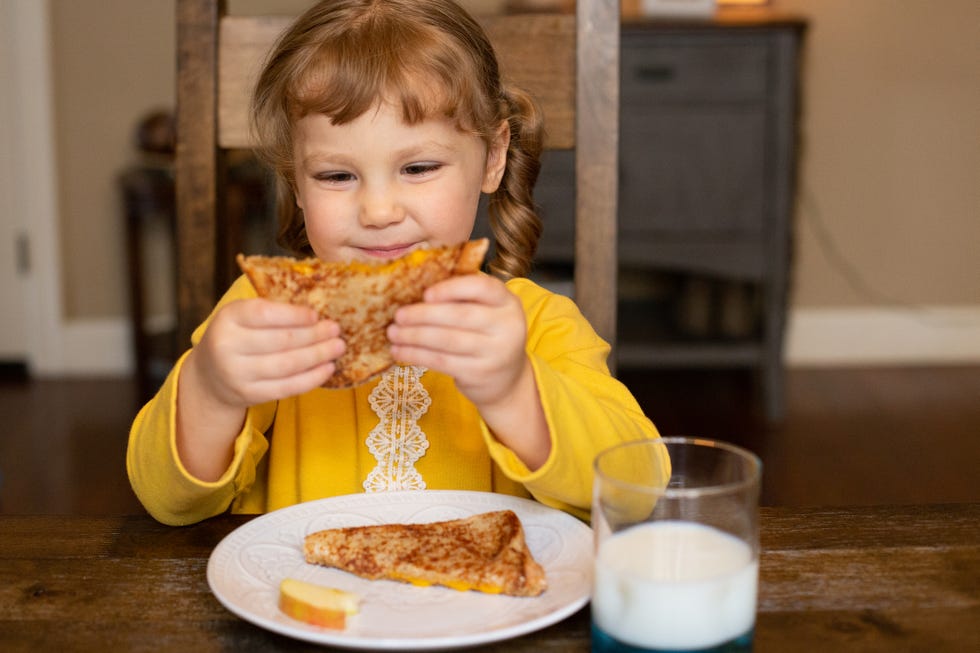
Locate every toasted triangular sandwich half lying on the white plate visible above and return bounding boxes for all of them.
[303,510,547,596]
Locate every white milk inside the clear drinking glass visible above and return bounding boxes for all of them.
[592,520,759,653]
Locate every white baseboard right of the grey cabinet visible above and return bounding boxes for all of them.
[786,305,980,367]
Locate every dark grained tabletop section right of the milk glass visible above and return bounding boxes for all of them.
[756,504,980,653]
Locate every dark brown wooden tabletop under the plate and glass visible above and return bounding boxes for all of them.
[0,504,980,653]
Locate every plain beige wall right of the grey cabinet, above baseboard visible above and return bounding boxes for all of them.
[778,0,980,307]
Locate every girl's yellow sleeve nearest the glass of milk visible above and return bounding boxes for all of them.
[483,279,659,517]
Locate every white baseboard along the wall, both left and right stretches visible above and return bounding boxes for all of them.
[39,306,980,376]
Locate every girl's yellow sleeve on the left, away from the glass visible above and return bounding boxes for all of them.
[126,279,275,525]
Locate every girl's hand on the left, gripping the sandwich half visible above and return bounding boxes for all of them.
[192,299,345,408]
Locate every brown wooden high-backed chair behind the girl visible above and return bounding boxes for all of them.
[176,0,620,365]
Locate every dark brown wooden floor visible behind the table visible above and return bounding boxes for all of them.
[0,366,980,515]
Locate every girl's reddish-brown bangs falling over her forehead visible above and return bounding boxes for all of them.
[289,18,493,136]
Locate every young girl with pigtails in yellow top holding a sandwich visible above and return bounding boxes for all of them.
[127,0,657,524]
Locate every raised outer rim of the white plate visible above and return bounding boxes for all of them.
[207,489,592,650]
